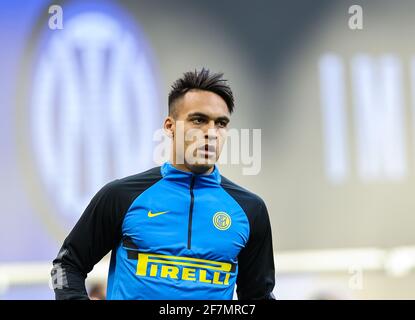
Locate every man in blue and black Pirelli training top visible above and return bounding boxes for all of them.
[52,69,275,299]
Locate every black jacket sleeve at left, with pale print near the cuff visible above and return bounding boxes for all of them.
[51,182,124,300]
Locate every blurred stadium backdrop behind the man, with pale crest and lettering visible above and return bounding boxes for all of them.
[0,0,415,299]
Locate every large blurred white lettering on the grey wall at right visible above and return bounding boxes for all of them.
[319,54,408,183]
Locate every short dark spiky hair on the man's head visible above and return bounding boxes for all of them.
[169,68,234,115]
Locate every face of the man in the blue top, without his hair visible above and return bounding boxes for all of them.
[165,90,230,173]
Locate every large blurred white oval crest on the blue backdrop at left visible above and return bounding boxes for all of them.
[30,12,160,222]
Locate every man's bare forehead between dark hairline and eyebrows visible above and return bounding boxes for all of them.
[177,90,229,118]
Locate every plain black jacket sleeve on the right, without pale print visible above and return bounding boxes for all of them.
[236,199,275,300]
